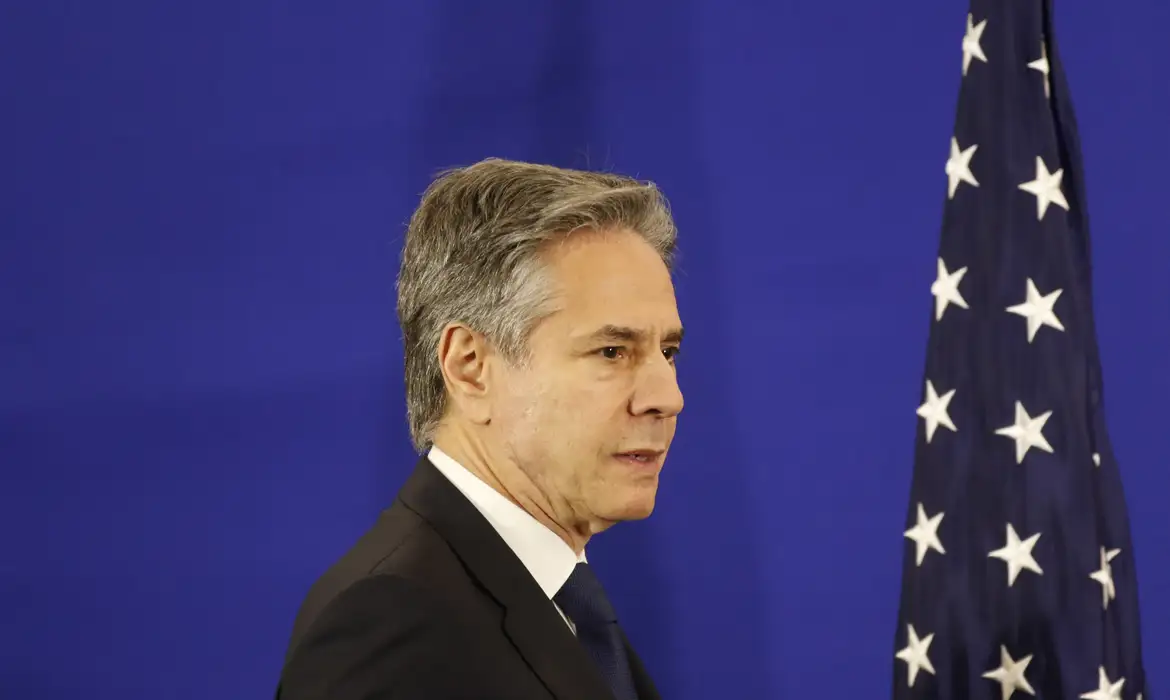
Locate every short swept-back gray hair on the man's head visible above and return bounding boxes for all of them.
[398,158,677,452]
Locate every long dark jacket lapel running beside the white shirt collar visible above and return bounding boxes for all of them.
[399,457,617,700]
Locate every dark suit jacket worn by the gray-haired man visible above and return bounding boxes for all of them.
[277,458,659,700]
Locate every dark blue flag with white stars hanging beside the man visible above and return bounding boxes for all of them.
[893,0,1149,700]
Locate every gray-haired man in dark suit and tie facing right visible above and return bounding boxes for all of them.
[278,159,682,700]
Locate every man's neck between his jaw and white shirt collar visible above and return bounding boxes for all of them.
[434,426,592,555]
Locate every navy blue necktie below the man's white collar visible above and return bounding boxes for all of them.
[552,562,638,700]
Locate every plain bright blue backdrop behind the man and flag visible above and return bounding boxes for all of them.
[0,0,1170,700]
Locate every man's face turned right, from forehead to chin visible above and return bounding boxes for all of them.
[493,231,682,530]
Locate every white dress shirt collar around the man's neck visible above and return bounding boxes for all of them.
[427,447,586,633]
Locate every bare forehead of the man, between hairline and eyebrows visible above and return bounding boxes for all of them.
[535,231,681,331]
